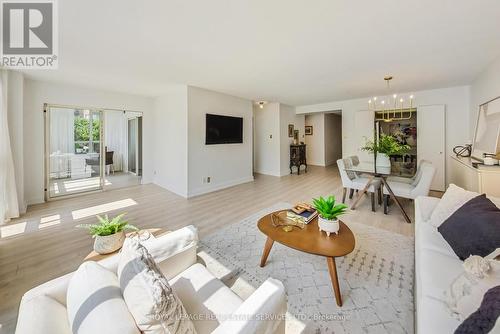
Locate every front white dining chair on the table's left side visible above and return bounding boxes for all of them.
[337,158,381,212]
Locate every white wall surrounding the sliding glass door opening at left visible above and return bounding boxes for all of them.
[23,78,154,204]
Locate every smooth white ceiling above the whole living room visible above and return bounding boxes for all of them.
[23,0,500,105]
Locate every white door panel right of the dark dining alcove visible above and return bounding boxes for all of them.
[417,105,446,191]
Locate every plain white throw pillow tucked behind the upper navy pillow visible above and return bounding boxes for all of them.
[429,183,479,228]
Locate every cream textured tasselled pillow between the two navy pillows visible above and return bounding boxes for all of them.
[445,255,500,321]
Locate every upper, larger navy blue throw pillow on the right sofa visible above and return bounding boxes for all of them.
[438,194,500,260]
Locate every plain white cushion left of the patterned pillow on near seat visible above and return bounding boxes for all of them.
[66,261,140,334]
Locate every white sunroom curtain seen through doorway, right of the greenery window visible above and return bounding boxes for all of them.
[104,110,127,171]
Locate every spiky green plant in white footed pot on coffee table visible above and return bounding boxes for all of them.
[313,196,347,236]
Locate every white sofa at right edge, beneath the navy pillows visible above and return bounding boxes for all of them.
[415,196,464,334]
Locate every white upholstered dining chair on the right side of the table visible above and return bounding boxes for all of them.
[383,160,436,214]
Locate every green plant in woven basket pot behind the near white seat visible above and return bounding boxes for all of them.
[76,213,138,254]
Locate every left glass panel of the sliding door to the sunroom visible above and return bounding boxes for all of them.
[45,105,104,199]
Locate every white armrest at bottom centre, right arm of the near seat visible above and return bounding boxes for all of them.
[214,278,287,334]
